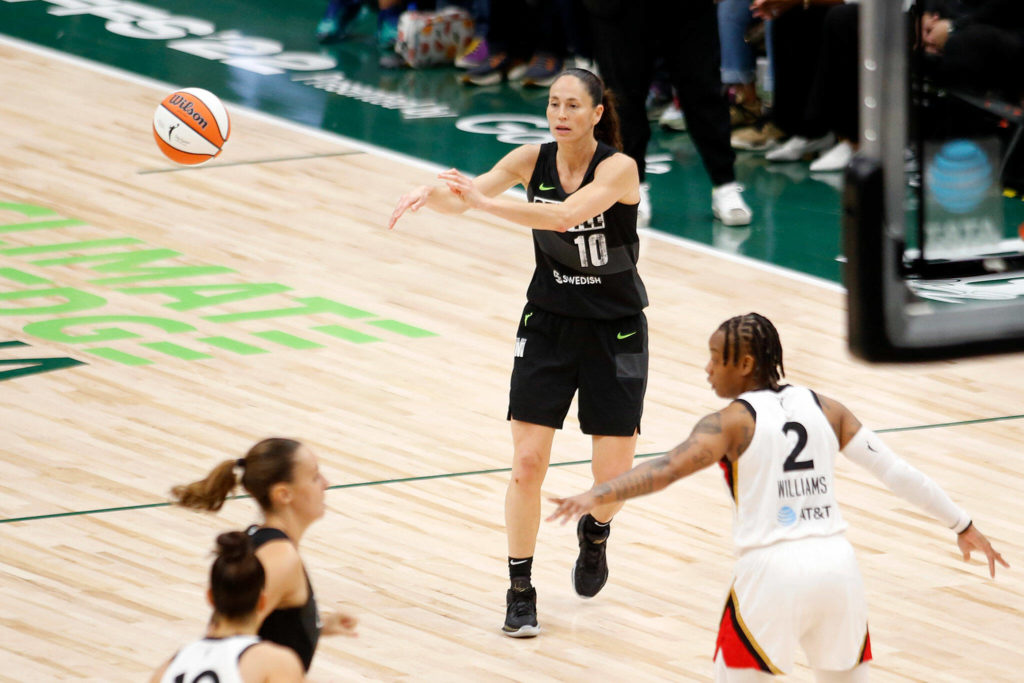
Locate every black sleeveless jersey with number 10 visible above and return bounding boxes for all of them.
[526,142,647,319]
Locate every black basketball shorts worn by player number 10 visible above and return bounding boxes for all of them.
[508,303,647,436]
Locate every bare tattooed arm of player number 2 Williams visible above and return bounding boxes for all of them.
[548,403,754,523]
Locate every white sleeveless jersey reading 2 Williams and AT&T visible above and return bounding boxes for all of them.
[721,385,846,554]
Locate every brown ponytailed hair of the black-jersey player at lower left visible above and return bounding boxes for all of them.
[171,438,302,512]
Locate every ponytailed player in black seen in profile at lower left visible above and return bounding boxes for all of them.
[171,438,355,671]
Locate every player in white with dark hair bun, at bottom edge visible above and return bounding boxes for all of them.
[150,531,305,683]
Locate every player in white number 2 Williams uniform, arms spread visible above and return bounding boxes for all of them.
[549,313,1009,683]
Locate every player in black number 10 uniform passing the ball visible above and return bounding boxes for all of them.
[388,69,647,638]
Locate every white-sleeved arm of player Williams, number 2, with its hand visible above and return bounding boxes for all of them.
[818,395,1010,579]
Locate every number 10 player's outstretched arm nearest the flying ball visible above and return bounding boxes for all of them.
[387,144,540,229]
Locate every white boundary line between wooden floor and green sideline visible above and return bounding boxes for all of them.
[0,34,846,292]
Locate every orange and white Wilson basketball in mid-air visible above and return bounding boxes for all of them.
[153,88,231,165]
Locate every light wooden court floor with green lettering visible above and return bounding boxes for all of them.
[0,41,1024,681]
